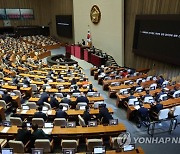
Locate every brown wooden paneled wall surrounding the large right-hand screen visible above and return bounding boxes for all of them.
[124,0,180,81]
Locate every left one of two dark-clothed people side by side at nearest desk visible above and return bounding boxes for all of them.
[16,122,31,145]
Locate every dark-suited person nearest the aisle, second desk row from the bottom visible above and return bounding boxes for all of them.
[98,104,113,124]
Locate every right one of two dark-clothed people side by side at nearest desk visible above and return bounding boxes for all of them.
[31,124,49,147]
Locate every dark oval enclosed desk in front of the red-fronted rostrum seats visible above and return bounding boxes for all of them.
[47,54,78,65]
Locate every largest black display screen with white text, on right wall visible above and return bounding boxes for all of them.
[133,15,180,65]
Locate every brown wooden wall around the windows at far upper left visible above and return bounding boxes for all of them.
[0,0,51,27]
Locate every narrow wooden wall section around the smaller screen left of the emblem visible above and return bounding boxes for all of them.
[50,0,74,43]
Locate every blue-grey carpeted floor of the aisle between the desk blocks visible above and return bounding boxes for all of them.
[51,48,180,154]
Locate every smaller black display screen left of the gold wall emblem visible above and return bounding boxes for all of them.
[56,15,72,38]
